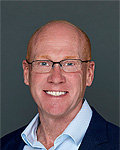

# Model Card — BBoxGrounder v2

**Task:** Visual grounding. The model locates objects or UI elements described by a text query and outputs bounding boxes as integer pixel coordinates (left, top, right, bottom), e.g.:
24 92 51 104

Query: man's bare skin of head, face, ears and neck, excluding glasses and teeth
23 21 95 149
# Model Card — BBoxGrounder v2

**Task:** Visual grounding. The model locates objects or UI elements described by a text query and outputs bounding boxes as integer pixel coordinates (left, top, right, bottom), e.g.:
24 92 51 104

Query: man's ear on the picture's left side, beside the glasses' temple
22 60 29 85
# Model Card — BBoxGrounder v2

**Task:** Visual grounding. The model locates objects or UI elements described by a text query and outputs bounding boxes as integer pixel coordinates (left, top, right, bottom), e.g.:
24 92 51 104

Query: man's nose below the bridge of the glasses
48 64 66 84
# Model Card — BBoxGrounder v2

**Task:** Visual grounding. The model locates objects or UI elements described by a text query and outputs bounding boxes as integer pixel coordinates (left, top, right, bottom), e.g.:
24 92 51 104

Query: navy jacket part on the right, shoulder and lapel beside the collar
80 107 120 150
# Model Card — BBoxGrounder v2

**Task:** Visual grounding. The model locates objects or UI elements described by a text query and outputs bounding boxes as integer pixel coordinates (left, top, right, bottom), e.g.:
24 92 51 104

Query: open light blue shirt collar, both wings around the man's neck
21 99 92 147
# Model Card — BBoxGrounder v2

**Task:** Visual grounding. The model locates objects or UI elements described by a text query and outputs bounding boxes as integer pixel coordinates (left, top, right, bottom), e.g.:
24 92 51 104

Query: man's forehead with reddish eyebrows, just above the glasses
31 38 79 61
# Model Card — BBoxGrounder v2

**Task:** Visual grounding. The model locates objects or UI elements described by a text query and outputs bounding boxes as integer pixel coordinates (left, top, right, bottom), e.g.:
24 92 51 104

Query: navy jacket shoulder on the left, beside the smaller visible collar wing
0 126 26 150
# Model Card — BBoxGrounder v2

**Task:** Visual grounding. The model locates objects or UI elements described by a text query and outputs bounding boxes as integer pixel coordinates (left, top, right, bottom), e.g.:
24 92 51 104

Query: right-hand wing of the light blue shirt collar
56 100 92 145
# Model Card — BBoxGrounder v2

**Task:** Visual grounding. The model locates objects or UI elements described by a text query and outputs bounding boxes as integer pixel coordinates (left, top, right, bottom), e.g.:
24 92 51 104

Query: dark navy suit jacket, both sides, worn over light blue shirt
1 108 120 150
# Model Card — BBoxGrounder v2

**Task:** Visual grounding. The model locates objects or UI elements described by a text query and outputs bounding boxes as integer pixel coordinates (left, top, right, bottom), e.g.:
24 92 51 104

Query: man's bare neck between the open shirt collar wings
37 116 69 149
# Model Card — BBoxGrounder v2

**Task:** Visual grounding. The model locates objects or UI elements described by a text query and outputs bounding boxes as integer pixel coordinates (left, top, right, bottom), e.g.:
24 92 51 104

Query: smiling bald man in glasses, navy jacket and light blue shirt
1 21 119 150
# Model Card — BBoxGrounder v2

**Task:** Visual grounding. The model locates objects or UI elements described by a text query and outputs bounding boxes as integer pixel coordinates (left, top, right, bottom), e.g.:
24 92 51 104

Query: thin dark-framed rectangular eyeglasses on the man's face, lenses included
26 59 91 73
